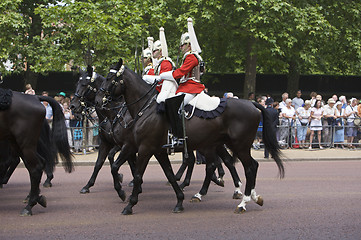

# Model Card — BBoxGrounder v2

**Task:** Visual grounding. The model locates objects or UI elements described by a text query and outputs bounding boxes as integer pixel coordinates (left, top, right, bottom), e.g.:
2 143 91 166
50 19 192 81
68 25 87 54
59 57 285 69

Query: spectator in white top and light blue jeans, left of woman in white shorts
296 100 311 148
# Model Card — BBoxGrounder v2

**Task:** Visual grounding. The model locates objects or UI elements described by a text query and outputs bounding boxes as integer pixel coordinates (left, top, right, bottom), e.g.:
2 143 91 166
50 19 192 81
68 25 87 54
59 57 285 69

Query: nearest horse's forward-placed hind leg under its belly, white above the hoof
191 152 219 202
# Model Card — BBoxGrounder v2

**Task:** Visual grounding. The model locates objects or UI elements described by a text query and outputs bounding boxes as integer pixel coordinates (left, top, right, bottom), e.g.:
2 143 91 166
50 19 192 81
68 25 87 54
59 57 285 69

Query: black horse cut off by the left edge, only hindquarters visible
0 92 73 215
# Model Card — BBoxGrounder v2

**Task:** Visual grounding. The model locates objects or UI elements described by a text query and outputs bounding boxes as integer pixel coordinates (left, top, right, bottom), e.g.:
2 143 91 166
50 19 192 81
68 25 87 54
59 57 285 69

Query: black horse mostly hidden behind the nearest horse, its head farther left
70 66 135 201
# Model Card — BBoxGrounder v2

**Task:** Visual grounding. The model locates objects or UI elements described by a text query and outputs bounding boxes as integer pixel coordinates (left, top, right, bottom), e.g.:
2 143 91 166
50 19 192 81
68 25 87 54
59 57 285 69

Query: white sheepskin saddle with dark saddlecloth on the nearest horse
184 92 227 119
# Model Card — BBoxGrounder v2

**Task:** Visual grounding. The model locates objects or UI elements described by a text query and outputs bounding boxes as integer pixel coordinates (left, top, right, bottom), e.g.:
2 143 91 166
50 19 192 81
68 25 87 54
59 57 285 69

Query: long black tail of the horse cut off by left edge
38 96 74 173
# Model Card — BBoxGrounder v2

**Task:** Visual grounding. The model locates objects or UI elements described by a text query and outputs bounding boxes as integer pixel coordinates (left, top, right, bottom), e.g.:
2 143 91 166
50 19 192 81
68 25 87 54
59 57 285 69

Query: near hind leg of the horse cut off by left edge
20 150 46 216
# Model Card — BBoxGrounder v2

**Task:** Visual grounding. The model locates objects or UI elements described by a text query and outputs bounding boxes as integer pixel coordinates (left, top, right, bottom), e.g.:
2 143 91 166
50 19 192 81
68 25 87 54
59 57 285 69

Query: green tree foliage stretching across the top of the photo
0 0 361 80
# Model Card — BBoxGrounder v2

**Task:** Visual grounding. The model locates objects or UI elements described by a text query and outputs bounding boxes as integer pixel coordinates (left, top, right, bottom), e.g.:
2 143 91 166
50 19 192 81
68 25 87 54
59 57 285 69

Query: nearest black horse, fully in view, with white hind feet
101 60 284 214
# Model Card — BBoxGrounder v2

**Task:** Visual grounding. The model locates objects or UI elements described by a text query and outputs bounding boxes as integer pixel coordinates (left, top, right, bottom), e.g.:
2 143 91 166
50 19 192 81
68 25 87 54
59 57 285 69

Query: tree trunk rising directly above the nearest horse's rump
243 37 257 98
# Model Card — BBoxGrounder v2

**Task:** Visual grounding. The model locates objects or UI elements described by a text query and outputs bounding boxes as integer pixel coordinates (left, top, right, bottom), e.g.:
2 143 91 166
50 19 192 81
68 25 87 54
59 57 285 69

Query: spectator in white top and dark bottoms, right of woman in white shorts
322 98 337 146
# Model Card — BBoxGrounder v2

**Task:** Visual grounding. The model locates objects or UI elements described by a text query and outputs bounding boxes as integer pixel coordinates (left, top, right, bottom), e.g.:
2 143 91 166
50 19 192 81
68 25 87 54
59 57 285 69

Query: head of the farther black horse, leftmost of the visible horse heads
70 65 98 119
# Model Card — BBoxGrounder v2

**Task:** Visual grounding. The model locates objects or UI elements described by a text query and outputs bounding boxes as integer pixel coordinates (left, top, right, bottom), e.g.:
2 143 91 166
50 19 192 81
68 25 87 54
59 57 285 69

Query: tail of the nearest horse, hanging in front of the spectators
252 102 285 178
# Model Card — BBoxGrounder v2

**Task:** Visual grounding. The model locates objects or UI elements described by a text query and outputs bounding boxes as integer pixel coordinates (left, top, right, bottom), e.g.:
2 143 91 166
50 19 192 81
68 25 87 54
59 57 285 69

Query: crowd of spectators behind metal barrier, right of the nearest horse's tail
249 90 361 154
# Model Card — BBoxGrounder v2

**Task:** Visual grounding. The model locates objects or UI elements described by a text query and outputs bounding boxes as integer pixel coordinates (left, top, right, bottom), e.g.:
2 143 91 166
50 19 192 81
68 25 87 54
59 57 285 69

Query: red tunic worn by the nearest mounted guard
173 54 205 94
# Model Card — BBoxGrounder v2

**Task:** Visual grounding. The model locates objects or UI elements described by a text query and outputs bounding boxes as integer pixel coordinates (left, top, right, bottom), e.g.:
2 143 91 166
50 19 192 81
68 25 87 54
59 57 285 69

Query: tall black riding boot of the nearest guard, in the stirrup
163 95 184 148
